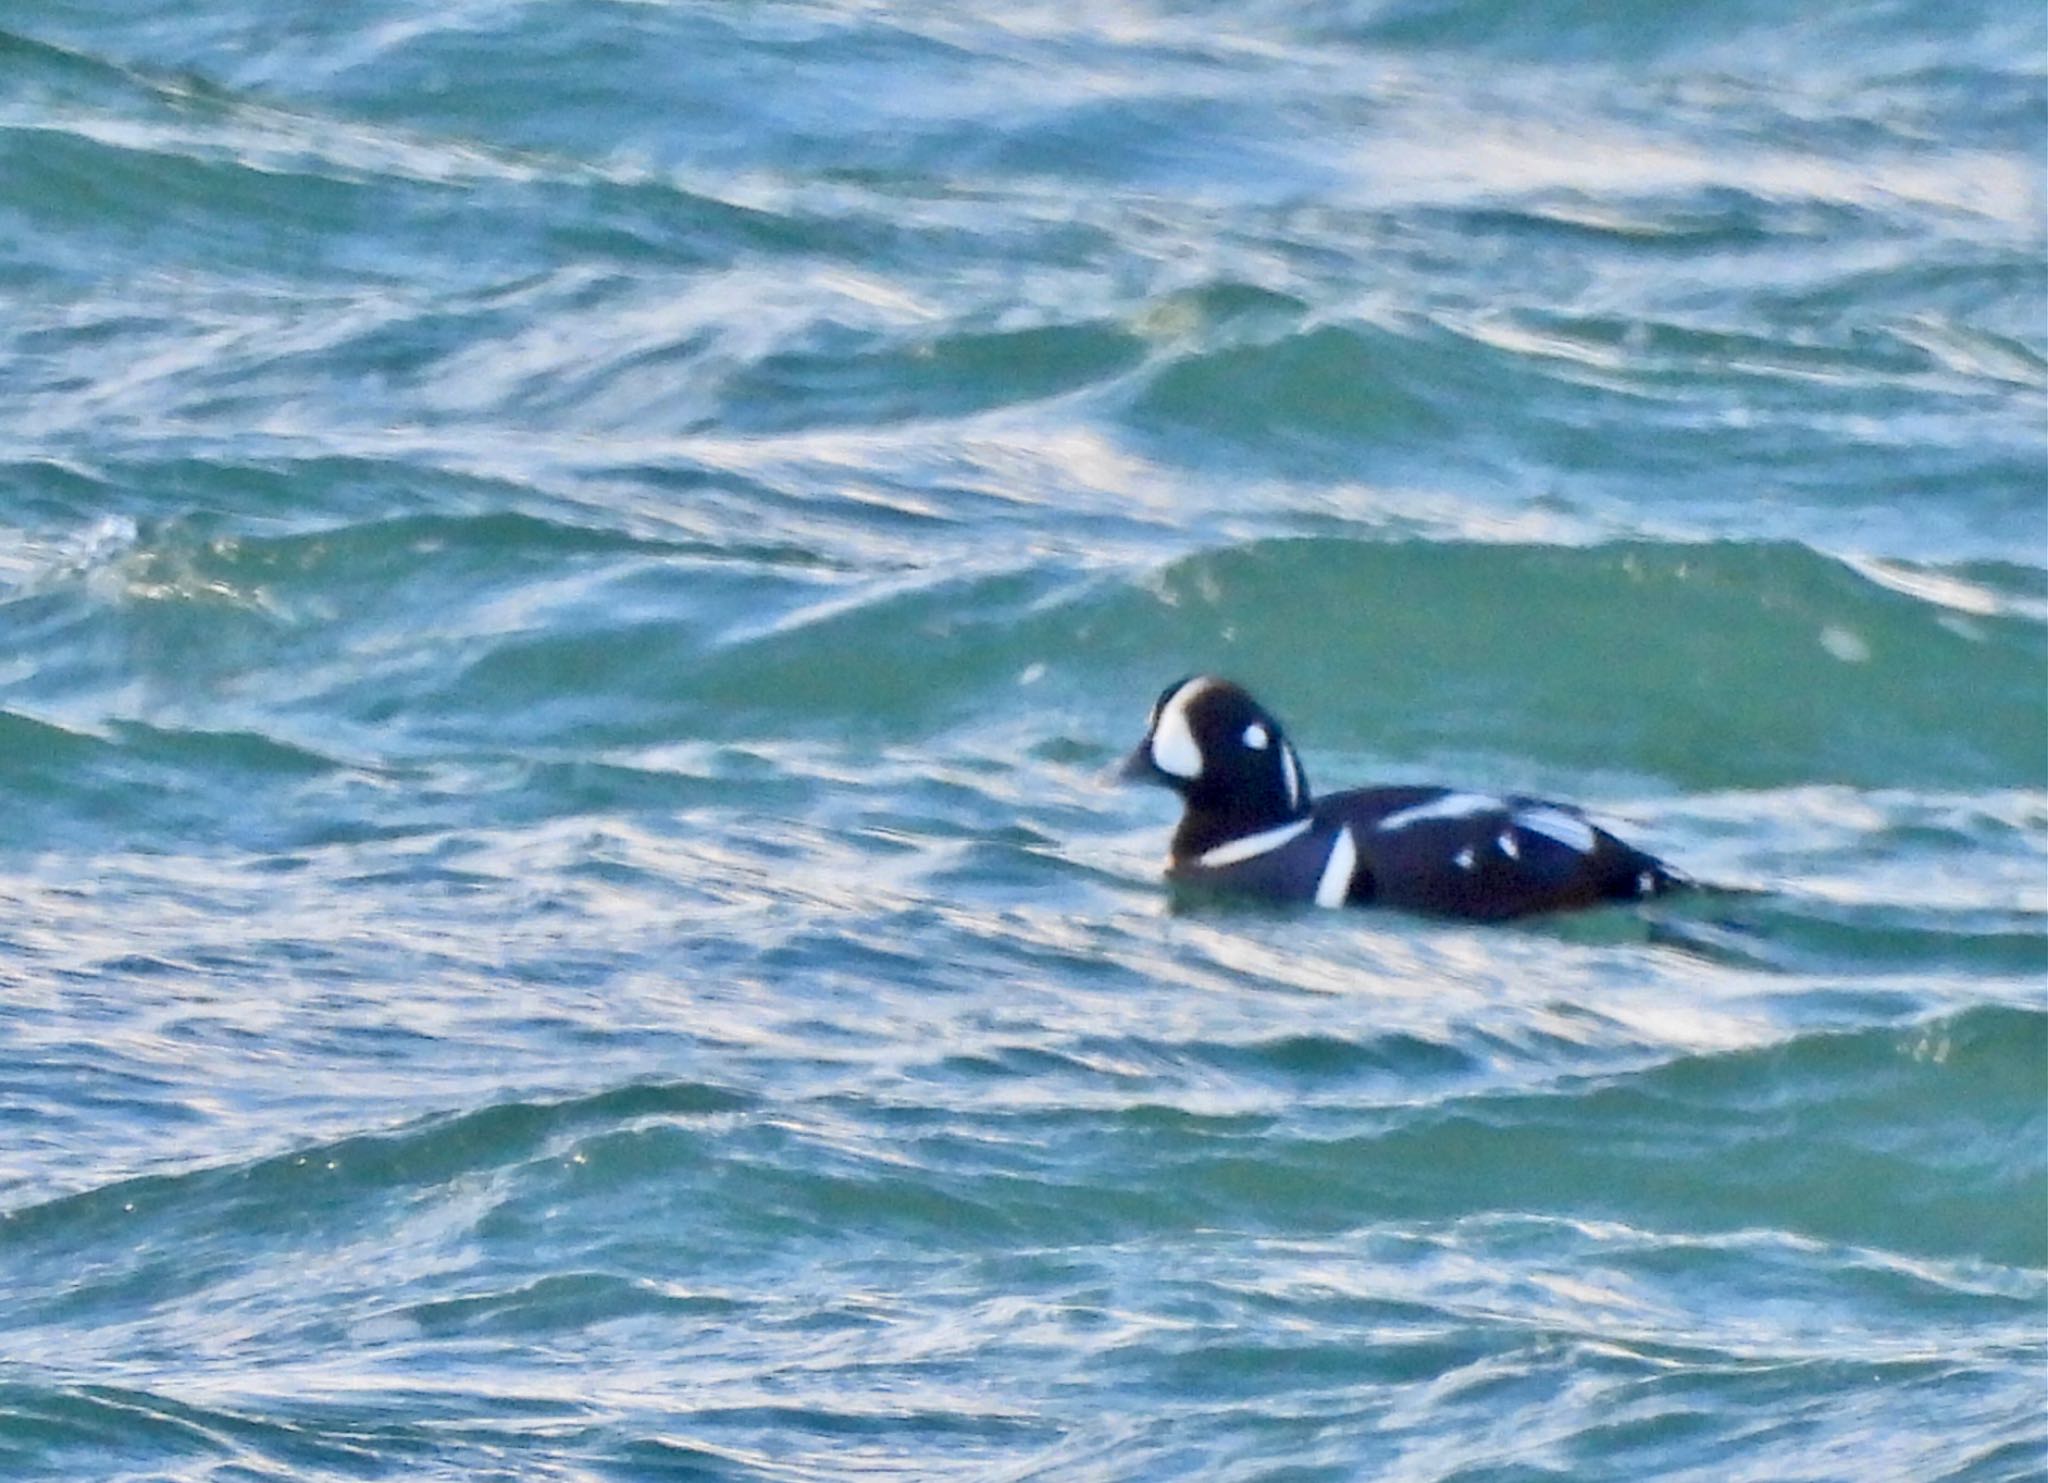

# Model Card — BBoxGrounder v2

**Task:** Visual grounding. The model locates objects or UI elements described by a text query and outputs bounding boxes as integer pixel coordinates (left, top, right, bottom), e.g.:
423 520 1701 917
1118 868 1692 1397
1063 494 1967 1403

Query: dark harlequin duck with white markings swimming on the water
1122 674 1686 922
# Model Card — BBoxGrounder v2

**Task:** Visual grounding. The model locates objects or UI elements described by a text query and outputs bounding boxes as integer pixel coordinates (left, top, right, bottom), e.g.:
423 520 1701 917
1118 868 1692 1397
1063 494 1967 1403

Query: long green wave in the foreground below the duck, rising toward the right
0 1006 2048 1278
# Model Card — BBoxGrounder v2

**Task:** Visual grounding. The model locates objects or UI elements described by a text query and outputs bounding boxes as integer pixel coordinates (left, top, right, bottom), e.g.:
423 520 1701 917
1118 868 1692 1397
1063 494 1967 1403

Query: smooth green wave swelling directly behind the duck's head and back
659 537 2048 789
